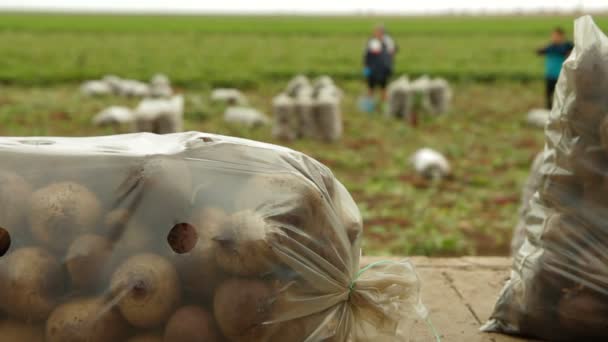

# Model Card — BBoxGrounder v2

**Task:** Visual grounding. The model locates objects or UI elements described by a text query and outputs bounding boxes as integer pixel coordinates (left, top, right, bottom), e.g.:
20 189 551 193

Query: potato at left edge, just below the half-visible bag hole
0 247 65 322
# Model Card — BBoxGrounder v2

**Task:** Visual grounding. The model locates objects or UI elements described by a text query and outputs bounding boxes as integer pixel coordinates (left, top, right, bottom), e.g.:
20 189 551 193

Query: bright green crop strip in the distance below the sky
0 13 608 89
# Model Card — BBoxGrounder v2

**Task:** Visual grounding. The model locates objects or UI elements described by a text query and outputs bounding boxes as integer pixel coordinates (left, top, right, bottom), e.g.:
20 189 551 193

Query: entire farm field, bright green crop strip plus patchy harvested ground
0 14 588 255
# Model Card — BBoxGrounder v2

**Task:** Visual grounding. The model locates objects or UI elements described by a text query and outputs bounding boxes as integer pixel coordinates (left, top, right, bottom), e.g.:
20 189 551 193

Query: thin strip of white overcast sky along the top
0 0 608 14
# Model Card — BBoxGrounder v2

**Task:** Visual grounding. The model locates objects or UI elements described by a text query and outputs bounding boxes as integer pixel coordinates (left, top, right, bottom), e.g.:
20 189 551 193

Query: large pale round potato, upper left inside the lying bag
29 182 101 251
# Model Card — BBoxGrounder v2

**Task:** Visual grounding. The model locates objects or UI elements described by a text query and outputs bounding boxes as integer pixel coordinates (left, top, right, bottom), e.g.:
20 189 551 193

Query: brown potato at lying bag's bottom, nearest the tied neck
213 278 274 341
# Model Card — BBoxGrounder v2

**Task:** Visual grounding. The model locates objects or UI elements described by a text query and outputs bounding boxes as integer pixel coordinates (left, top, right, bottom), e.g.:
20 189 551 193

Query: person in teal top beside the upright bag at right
536 27 574 109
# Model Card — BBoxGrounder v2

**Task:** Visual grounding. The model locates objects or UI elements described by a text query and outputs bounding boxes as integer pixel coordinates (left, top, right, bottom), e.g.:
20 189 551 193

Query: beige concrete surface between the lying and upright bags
361 257 533 342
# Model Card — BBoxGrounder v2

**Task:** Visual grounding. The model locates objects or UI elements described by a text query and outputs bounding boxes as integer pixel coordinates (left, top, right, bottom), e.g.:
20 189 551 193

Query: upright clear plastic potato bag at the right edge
483 16 608 341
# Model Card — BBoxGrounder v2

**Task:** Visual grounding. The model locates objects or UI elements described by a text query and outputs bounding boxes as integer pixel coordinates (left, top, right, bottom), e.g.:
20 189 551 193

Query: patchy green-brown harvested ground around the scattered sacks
0 81 543 255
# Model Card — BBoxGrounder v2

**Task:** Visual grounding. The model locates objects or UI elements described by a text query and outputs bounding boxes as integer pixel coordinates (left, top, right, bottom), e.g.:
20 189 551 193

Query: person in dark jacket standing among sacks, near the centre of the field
363 25 397 111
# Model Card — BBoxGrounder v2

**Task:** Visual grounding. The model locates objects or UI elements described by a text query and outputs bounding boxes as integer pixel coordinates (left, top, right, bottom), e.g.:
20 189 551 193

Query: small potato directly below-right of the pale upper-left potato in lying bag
65 234 112 289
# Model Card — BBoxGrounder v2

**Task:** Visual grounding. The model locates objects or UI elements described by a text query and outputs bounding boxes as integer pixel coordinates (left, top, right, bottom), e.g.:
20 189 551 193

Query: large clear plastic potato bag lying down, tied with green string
0 133 425 342
